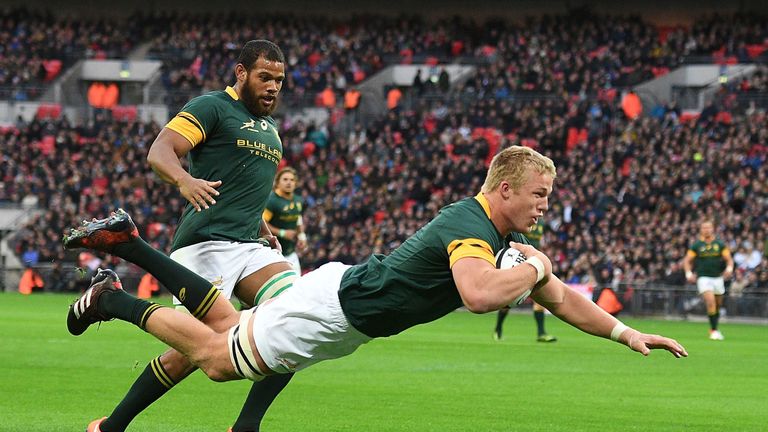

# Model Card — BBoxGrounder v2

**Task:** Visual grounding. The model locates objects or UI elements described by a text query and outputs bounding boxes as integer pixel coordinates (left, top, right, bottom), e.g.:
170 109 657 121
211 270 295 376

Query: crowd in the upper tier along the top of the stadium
0 9 768 108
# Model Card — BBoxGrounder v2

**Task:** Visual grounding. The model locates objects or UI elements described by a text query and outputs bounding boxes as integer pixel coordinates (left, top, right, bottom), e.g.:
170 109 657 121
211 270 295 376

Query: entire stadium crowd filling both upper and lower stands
0 9 768 296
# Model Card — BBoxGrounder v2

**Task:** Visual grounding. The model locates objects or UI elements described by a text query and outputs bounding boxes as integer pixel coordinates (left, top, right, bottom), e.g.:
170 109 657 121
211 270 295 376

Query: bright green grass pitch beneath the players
0 294 768 432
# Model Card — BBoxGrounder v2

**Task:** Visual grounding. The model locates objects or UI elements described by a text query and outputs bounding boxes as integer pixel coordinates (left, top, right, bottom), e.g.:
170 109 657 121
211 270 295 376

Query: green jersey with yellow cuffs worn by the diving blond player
339 194 528 337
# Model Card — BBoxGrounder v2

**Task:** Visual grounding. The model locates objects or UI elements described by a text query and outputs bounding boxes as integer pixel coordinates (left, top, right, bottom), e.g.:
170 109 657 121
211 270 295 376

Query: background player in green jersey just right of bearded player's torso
263 167 307 274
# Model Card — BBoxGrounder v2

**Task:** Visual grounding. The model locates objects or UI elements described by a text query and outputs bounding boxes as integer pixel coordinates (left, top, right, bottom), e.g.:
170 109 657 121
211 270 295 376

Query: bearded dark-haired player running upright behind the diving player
87 40 297 432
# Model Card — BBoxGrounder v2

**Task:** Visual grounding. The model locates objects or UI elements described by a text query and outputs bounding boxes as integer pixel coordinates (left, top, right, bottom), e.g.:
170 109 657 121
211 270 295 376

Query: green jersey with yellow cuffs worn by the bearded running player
166 87 283 250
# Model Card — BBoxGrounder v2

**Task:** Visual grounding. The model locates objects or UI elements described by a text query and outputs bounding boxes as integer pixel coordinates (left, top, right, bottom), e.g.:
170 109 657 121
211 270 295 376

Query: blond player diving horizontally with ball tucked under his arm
64 146 688 430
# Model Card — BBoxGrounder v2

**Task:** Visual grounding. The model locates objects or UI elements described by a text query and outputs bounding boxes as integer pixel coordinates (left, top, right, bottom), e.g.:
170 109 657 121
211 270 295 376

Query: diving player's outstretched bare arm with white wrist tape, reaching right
531 275 688 358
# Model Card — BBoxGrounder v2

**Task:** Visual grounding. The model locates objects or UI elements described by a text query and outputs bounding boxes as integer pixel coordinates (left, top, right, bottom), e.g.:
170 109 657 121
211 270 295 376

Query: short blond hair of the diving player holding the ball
481 146 557 193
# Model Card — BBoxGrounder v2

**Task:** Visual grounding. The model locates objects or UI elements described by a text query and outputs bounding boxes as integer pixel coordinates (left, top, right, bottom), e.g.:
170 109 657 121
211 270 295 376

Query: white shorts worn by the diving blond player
252 262 371 373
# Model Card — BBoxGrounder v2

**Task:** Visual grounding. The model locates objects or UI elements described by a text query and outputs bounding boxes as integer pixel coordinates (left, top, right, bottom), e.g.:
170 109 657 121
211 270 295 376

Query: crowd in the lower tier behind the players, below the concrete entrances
7 86 768 296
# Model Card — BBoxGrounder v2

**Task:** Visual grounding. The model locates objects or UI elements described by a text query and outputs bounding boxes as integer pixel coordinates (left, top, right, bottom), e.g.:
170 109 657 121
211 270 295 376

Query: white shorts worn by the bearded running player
171 240 287 305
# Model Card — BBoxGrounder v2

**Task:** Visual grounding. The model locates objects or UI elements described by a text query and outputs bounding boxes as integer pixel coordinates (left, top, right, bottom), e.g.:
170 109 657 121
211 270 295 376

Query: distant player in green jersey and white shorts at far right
683 220 733 340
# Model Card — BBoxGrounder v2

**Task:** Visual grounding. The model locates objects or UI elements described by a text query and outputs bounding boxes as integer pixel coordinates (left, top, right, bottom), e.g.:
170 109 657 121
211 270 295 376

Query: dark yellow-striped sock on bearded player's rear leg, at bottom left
100 357 176 432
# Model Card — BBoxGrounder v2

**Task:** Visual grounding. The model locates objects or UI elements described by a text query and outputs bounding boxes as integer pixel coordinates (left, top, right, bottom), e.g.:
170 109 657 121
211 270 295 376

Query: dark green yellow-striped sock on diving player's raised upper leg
113 239 219 319
